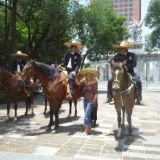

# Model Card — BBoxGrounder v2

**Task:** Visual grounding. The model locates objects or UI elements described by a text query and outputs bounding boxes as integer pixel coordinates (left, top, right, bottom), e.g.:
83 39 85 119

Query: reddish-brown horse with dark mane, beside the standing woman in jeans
21 61 82 131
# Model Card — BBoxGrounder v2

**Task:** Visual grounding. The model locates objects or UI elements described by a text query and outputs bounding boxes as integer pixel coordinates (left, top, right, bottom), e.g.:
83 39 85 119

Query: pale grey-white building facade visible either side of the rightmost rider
91 52 160 87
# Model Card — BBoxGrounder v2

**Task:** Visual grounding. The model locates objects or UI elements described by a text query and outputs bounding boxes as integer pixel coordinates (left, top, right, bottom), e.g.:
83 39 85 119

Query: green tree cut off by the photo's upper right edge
145 0 160 48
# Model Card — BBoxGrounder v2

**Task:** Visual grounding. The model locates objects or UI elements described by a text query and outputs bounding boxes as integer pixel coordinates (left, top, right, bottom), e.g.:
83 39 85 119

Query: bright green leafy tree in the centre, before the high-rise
68 0 127 60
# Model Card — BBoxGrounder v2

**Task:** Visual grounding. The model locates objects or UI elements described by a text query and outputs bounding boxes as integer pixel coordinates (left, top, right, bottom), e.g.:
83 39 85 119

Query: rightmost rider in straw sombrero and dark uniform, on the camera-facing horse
106 41 142 105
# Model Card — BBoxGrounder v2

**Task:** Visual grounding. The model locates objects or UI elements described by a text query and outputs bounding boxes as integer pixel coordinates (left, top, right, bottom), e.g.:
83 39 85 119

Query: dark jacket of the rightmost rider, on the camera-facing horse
113 52 137 74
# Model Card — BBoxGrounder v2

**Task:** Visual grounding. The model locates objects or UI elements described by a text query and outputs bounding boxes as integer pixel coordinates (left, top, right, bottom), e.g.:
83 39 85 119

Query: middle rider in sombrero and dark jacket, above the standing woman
62 40 83 99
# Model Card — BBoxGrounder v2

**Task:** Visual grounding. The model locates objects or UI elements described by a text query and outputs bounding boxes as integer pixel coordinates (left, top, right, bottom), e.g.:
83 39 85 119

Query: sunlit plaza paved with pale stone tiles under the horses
0 90 160 160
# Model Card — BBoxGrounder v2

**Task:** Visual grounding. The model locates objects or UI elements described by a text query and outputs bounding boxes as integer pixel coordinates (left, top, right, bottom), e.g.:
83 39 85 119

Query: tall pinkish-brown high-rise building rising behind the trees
90 0 141 25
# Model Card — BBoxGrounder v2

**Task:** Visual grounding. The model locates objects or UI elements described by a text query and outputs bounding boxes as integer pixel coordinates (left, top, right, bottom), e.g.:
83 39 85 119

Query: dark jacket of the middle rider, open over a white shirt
62 52 81 73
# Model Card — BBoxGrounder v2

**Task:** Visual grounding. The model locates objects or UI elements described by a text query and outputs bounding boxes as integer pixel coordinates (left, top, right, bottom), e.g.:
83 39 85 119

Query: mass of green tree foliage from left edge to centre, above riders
0 0 126 63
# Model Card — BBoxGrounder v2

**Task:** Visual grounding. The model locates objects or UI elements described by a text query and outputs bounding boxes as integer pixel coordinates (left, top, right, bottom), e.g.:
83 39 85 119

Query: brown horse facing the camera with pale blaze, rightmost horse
112 62 135 137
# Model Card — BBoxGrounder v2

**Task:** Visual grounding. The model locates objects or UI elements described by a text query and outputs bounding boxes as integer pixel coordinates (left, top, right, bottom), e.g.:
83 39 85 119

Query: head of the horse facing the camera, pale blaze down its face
112 61 126 91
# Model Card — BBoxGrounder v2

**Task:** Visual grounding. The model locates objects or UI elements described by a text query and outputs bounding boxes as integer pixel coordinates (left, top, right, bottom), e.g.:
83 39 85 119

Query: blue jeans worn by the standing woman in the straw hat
83 99 93 127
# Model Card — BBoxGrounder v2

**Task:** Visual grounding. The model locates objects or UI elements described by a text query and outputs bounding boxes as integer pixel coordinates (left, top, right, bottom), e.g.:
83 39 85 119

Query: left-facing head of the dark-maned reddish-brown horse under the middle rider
21 61 35 77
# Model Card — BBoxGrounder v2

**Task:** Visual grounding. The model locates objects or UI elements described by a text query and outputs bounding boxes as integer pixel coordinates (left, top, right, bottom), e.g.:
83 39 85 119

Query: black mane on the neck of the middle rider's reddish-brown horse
35 62 57 78
